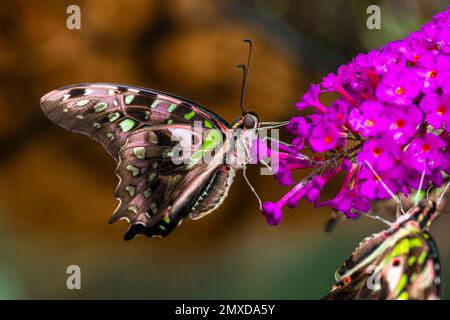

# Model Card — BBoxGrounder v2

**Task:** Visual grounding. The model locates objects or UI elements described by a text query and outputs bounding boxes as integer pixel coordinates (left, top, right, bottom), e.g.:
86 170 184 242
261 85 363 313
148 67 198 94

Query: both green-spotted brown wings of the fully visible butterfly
41 83 243 240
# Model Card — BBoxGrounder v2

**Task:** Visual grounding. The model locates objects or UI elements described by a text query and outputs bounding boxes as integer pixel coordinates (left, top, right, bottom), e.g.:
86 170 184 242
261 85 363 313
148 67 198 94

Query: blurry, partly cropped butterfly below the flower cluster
323 191 443 300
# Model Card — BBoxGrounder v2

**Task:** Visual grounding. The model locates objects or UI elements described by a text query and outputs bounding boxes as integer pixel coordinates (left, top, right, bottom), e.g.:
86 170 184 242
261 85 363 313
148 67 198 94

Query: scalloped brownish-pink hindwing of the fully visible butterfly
111 125 227 235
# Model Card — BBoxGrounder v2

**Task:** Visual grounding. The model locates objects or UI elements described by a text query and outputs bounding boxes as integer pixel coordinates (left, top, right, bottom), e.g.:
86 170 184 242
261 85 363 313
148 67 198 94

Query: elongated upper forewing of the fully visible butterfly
41 83 229 159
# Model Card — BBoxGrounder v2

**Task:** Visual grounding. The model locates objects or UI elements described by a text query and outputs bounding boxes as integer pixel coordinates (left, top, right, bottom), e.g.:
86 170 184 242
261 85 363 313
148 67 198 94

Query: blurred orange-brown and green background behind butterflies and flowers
0 0 450 299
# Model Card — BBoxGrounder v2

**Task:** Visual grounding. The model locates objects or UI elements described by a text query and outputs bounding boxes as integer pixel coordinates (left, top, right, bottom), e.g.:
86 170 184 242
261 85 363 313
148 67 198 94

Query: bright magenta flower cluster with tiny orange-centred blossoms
262 8 450 225
